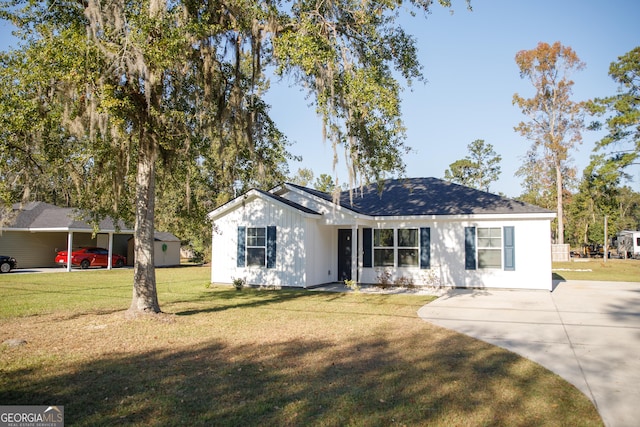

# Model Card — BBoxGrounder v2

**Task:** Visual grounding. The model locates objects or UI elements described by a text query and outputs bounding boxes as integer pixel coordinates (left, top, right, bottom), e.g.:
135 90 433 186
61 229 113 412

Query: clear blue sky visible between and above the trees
0 0 640 196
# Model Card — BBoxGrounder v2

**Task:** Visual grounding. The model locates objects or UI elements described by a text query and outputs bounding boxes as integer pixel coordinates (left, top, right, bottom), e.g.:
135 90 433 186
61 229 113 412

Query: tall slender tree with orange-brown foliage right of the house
513 42 584 244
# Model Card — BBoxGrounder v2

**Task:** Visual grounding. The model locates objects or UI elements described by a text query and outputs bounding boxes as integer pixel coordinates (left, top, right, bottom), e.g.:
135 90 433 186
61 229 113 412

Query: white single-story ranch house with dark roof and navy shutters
209 178 556 290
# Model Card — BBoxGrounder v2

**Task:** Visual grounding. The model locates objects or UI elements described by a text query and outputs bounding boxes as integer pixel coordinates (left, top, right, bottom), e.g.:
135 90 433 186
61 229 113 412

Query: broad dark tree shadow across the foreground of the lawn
0 331 599 426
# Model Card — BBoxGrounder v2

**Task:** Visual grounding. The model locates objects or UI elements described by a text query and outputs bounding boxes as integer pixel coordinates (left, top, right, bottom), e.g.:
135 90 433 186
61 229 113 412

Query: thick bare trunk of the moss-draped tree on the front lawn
129 130 160 315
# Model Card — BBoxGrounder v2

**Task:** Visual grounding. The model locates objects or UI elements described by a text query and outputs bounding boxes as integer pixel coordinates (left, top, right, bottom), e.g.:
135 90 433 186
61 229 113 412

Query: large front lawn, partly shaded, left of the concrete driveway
0 267 602 426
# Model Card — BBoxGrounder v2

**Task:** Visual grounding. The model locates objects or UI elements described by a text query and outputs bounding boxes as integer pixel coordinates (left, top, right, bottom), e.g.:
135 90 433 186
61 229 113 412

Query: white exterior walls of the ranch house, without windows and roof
211 191 552 290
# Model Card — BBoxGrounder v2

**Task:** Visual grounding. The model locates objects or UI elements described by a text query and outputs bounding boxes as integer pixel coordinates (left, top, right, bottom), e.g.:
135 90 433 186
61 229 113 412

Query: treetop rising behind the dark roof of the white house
444 139 502 191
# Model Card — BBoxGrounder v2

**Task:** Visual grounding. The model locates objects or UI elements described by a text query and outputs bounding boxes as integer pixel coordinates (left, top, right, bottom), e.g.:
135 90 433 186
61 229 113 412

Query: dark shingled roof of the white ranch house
288 178 553 216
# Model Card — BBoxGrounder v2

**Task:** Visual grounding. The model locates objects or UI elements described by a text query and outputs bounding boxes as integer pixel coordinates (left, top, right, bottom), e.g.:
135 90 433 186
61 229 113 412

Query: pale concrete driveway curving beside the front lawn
418 281 640 427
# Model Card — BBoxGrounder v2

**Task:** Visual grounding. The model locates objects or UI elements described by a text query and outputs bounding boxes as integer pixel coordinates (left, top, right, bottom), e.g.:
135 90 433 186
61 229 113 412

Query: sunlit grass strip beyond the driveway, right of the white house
553 258 640 282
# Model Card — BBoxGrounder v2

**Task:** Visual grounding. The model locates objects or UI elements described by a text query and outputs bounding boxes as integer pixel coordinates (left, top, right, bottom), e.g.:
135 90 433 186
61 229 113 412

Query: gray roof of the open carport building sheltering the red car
6 202 130 231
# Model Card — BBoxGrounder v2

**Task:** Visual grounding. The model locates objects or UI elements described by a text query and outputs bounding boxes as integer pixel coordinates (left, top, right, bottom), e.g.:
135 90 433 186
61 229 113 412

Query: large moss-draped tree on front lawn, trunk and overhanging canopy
0 0 470 313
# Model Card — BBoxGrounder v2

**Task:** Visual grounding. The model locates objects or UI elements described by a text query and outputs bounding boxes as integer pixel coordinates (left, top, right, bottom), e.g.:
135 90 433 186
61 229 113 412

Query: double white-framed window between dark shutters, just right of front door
373 228 420 267
